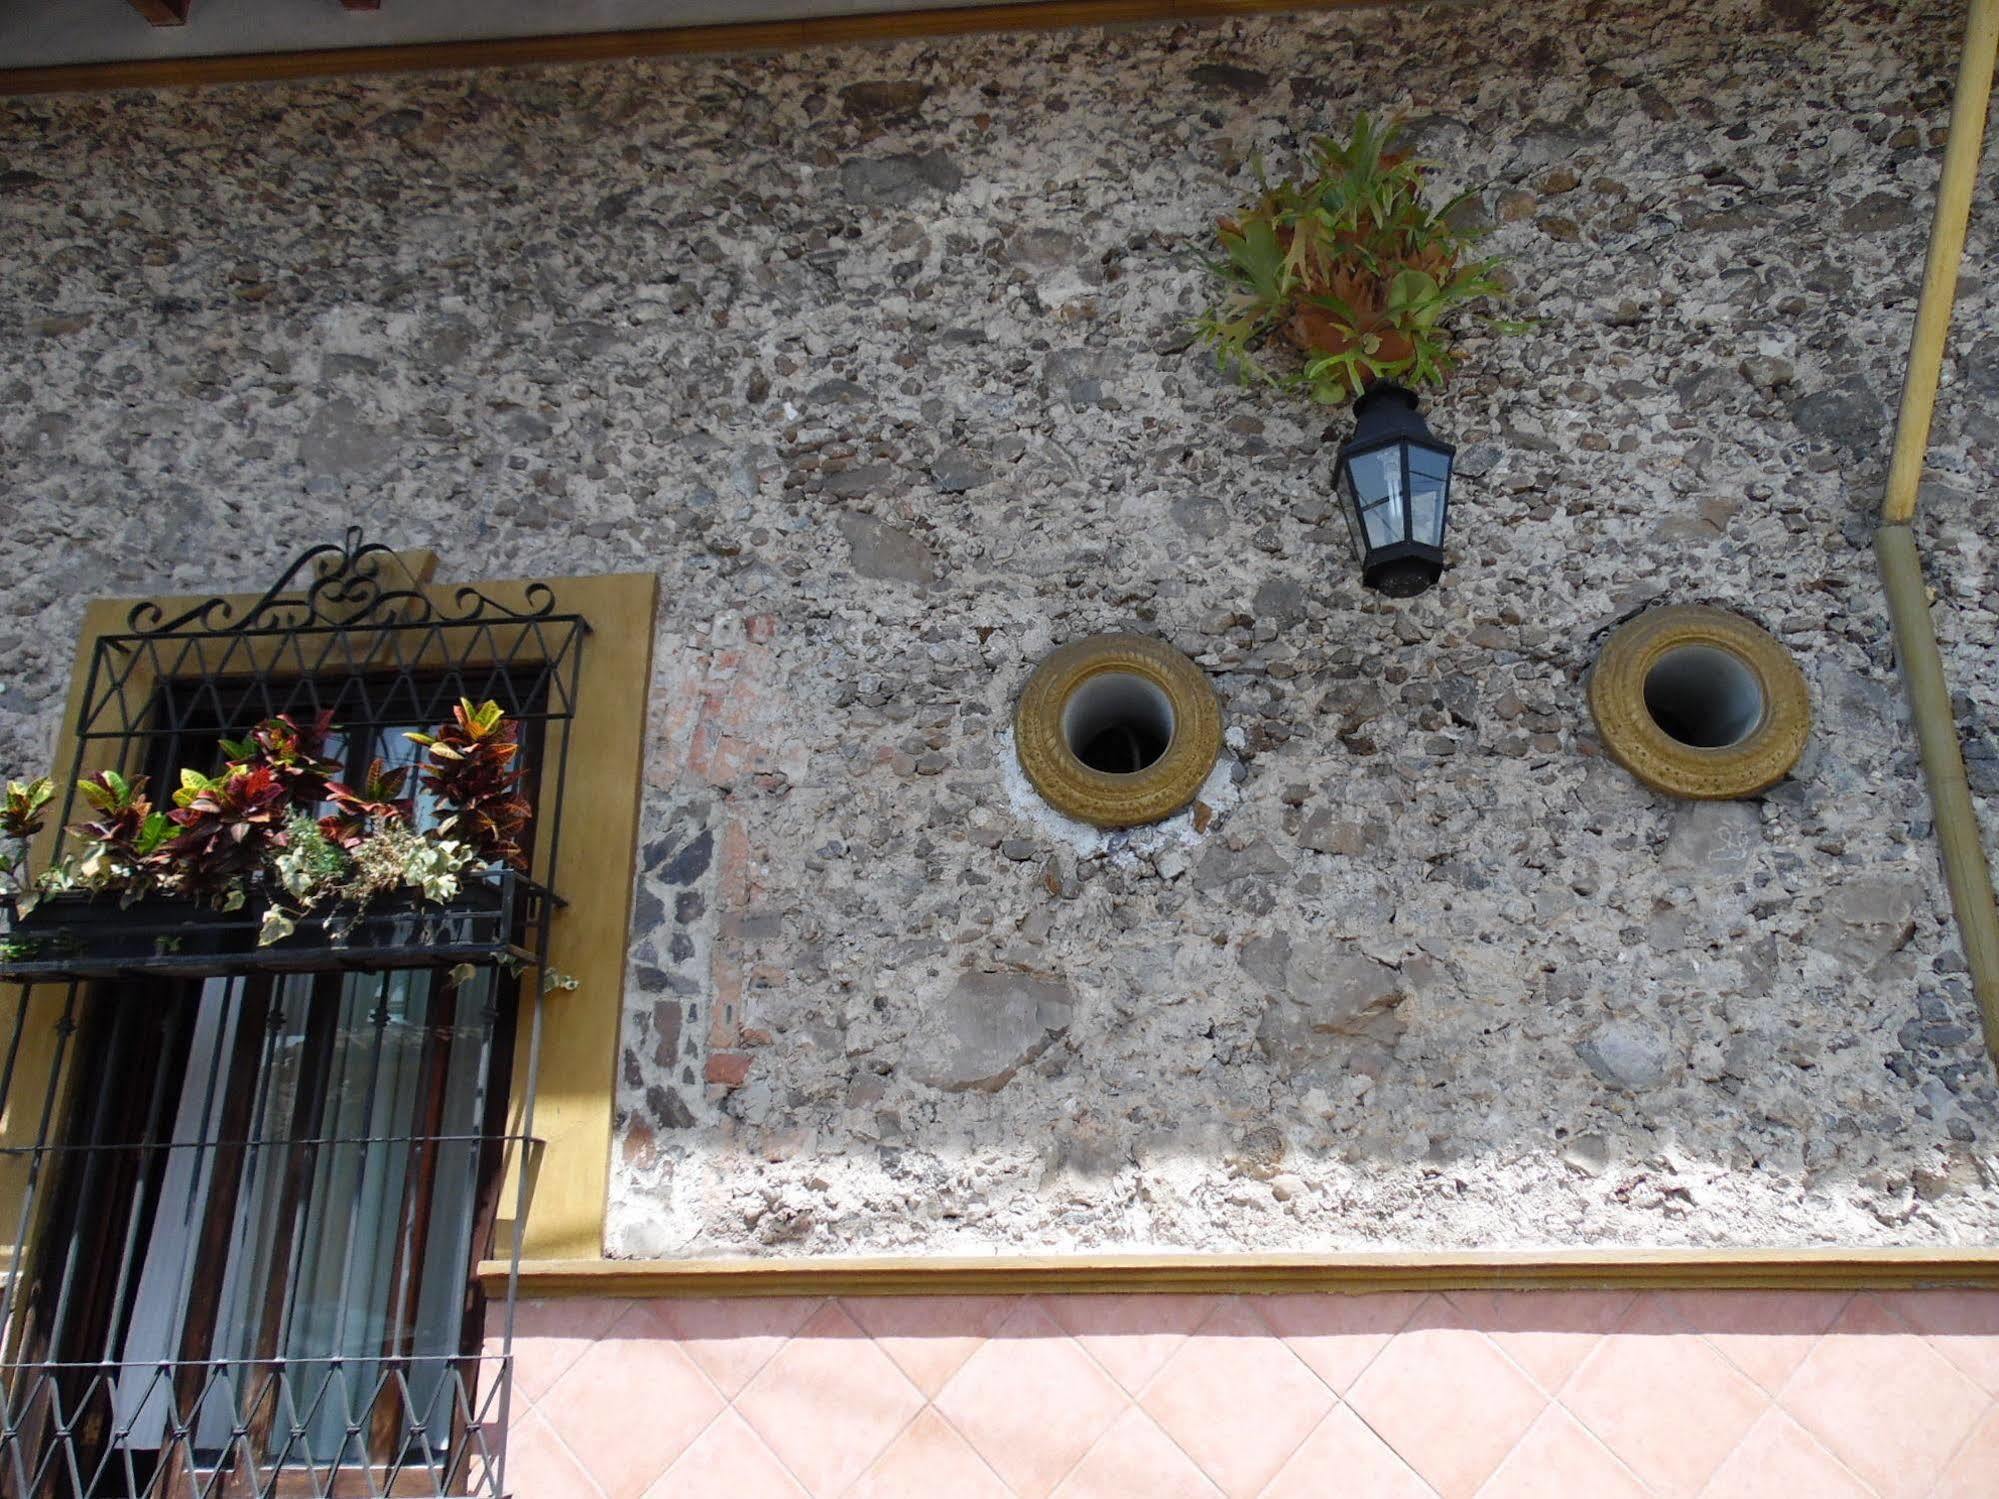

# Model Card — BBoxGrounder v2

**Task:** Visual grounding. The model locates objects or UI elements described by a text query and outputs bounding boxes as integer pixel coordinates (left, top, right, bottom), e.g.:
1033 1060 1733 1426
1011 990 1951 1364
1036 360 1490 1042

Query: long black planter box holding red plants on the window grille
0 869 560 983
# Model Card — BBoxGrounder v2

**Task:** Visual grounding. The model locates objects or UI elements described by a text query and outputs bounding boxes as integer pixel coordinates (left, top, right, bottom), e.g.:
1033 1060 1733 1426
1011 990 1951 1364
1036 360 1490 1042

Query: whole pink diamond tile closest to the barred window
536 1303 722 1499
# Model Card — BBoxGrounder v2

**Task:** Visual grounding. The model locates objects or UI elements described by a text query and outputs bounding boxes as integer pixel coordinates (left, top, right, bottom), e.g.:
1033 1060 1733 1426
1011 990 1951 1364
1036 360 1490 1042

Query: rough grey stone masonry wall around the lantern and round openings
0 0 1999 1255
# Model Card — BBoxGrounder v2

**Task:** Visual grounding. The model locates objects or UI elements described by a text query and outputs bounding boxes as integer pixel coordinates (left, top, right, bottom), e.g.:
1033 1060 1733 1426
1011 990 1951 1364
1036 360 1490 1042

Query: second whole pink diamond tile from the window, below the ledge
736 1303 924 1499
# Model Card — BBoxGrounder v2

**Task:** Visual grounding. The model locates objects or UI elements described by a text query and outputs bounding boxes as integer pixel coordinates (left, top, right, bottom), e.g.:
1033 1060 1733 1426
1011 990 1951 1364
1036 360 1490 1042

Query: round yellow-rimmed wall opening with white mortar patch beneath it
1013 636 1221 827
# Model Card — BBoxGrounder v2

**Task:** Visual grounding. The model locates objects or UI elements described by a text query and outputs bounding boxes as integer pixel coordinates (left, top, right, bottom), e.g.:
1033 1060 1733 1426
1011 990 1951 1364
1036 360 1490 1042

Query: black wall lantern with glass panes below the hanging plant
1337 382 1457 598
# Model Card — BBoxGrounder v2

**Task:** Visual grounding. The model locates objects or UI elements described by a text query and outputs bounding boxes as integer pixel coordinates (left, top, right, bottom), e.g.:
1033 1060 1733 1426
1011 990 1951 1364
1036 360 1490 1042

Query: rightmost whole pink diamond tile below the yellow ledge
1779 1293 1989 1499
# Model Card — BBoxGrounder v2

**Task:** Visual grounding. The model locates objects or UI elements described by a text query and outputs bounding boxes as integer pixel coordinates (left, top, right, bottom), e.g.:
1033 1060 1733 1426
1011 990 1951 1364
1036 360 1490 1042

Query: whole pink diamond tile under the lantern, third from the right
1347 1297 1547 1499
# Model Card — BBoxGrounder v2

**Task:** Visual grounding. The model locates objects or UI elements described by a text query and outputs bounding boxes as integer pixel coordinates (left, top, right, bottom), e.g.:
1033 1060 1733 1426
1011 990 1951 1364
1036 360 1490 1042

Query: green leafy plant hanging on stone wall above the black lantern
1195 114 1529 404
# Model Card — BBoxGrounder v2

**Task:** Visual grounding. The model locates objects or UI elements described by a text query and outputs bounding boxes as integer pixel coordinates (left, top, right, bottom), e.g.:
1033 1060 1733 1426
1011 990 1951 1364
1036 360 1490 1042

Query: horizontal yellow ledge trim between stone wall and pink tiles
480 1247 1999 1299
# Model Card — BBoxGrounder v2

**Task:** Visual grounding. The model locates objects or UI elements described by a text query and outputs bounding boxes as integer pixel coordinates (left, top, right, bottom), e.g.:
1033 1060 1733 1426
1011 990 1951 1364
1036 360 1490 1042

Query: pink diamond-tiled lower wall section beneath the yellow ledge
491 1291 1999 1499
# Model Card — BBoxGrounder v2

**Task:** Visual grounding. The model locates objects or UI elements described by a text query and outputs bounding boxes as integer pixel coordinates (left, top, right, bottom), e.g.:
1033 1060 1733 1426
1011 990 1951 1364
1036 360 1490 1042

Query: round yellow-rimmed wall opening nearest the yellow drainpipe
1589 604 1811 799
